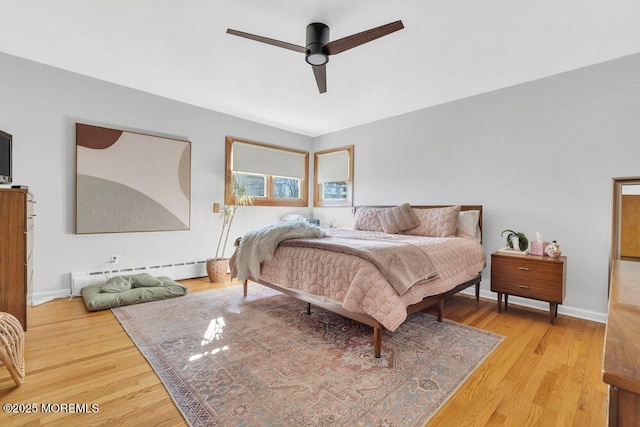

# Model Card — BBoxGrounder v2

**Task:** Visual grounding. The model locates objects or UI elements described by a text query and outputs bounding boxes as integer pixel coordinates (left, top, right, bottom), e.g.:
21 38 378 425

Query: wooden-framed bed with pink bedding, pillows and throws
231 203 486 357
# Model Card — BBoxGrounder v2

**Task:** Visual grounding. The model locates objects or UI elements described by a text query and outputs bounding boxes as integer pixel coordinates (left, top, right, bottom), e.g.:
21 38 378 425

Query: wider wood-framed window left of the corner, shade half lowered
225 137 309 206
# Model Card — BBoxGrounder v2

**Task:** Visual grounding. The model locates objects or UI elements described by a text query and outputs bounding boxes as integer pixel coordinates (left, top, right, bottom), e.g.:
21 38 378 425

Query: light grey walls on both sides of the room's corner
0 50 640 319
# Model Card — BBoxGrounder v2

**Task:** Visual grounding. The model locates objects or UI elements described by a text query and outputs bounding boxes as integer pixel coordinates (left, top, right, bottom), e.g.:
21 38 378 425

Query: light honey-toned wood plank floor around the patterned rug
0 278 607 427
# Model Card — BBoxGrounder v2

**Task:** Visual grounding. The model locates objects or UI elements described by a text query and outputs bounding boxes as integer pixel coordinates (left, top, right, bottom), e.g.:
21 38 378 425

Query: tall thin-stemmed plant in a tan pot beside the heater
207 176 253 283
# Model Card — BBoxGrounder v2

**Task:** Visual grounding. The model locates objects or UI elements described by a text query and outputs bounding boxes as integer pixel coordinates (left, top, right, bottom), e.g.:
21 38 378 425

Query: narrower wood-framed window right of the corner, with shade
313 145 353 207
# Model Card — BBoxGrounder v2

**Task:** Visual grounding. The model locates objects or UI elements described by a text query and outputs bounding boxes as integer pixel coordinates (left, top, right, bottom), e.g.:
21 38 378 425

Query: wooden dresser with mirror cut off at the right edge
602 260 640 426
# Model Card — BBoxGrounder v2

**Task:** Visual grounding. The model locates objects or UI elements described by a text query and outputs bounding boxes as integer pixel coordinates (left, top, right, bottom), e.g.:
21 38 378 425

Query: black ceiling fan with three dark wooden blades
227 21 404 93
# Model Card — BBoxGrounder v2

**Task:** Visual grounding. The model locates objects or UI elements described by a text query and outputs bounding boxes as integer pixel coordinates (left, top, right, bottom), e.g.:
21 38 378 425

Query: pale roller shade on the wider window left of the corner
231 142 305 179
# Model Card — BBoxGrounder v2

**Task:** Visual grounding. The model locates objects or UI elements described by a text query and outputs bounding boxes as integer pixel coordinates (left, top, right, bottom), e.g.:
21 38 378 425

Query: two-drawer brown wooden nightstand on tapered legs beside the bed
491 252 567 324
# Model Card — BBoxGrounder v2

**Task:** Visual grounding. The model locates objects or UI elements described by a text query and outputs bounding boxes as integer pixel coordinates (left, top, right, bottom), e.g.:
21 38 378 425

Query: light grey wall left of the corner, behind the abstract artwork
0 53 312 295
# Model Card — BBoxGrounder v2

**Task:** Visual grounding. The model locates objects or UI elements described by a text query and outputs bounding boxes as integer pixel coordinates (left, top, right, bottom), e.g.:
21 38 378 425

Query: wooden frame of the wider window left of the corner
224 136 309 207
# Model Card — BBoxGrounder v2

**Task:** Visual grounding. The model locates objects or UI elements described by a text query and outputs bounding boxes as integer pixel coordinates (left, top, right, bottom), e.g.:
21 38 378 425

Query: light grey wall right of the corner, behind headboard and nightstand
314 55 640 320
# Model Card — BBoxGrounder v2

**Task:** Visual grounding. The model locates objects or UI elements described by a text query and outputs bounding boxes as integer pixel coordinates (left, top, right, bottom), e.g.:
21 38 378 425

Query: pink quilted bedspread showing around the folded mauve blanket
254 229 485 331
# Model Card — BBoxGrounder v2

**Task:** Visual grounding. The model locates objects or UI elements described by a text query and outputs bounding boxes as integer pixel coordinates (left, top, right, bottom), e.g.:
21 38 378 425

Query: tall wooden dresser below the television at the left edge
0 189 35 331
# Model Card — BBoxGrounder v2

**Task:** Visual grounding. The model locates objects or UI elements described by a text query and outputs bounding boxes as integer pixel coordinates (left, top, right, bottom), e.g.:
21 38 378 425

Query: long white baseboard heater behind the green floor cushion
71 261 207 295
